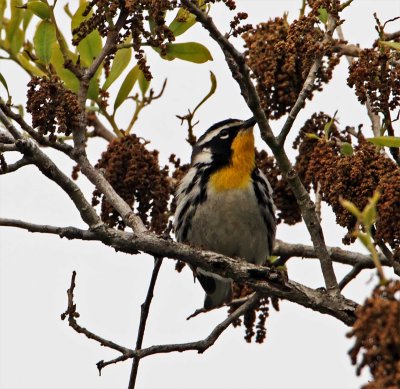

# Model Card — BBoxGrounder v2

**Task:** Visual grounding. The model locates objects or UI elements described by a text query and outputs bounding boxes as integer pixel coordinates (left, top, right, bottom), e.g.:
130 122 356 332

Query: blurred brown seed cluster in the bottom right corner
347 281 400 389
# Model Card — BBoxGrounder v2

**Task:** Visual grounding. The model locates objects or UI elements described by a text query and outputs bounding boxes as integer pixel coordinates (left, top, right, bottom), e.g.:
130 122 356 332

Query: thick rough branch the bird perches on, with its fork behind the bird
0 218 356 325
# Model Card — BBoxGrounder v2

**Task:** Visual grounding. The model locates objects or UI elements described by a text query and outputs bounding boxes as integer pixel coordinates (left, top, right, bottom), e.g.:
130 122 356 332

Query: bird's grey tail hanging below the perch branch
196 268 232 309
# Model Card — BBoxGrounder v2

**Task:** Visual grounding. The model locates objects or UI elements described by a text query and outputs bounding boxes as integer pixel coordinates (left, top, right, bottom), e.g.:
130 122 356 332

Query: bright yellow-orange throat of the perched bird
210 128 255 192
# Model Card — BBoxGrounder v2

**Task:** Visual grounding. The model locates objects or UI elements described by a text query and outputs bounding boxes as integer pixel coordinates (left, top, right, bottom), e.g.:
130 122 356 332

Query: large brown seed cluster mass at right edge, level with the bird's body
295 114 400 249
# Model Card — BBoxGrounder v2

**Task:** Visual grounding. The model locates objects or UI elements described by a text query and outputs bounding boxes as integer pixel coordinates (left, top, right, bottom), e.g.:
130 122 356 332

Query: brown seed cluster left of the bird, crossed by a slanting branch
92 135 171 234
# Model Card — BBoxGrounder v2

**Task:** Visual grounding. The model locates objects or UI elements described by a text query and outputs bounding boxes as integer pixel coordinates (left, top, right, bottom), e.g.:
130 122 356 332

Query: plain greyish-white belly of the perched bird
188 185 269 264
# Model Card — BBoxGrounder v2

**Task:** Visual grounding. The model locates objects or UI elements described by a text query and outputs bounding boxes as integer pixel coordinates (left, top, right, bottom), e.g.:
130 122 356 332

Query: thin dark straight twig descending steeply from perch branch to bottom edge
128 257 163 389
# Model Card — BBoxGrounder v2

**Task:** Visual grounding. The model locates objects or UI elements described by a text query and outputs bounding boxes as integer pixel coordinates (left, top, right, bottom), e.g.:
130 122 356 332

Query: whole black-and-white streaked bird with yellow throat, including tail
174 118 276 309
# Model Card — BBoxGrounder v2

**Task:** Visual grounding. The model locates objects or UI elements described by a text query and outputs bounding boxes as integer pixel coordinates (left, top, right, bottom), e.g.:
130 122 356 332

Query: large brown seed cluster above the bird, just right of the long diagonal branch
242 11 339 119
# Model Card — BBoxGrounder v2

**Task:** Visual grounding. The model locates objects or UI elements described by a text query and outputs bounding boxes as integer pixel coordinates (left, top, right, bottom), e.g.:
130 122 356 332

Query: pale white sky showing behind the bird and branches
0 0 400 389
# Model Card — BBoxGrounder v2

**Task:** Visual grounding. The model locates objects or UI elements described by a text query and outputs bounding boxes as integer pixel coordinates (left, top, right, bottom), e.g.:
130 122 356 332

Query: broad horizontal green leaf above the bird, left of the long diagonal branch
155 42 213 63
